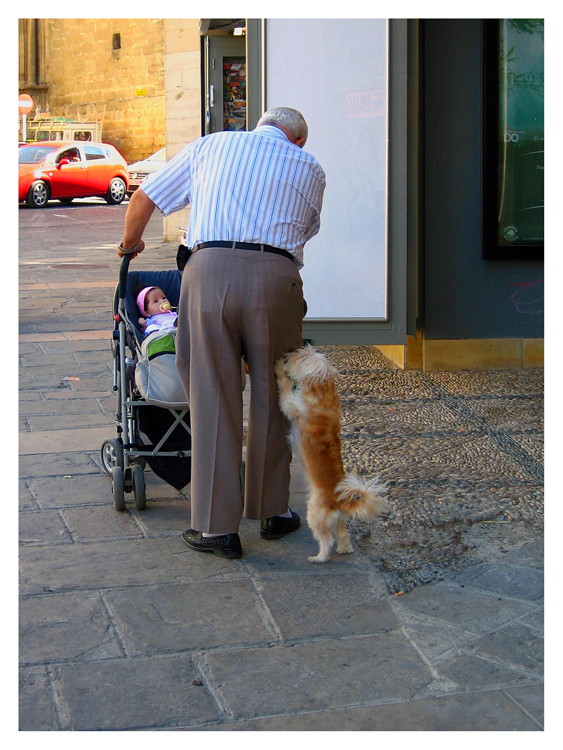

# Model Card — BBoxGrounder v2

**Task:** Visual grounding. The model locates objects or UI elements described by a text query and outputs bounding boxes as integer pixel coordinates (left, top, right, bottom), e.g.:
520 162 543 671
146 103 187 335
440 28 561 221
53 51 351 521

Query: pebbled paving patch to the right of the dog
320 346 544 593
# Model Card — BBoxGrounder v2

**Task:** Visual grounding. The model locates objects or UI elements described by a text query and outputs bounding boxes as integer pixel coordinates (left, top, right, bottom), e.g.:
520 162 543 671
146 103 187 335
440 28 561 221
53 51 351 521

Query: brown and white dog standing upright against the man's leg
275 345 391 563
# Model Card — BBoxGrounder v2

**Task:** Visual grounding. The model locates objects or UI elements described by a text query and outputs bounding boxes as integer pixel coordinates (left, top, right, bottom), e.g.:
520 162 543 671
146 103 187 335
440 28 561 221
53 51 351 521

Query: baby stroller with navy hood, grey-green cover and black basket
101 255 191 511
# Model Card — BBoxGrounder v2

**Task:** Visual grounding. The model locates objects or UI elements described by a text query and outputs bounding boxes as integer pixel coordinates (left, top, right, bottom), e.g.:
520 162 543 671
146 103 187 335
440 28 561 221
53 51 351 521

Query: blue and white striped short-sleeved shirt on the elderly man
142 125 326 268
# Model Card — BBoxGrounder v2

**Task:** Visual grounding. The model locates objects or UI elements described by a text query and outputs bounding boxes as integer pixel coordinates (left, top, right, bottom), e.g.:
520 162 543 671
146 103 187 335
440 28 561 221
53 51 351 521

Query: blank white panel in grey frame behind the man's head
265 19 388 320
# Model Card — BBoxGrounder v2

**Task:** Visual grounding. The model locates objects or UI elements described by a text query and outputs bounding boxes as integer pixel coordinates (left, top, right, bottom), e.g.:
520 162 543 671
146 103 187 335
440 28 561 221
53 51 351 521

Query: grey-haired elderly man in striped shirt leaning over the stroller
118 107 325 558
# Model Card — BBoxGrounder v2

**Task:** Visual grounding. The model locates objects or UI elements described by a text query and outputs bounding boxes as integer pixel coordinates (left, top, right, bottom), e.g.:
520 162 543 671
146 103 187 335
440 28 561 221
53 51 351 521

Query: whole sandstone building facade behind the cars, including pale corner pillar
19 18 208 239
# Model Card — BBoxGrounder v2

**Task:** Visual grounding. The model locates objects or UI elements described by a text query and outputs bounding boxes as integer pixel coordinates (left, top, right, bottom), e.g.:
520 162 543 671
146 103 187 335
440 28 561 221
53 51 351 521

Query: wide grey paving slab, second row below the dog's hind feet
202 633 432 718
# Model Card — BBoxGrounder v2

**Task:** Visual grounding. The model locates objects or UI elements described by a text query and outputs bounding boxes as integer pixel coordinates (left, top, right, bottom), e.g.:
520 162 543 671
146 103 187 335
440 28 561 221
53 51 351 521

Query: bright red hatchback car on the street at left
18 141 129 208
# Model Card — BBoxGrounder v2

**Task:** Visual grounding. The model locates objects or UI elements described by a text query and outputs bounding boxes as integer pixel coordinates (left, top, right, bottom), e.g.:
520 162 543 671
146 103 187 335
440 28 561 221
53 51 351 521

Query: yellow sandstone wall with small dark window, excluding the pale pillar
45 18 166 163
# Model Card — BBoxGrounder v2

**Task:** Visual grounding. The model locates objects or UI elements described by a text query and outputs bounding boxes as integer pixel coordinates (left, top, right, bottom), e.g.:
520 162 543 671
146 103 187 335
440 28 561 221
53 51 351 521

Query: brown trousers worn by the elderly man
176 247 303 534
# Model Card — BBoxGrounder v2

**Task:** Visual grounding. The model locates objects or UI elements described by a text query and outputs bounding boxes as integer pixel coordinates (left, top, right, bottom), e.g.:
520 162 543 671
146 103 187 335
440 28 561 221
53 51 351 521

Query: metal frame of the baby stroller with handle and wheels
101 255 191 511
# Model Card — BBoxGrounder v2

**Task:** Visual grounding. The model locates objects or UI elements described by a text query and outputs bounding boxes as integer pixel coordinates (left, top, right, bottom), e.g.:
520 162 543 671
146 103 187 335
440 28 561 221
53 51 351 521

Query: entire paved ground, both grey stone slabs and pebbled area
18 201 544 741
